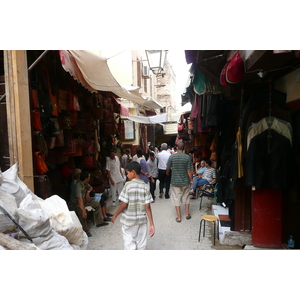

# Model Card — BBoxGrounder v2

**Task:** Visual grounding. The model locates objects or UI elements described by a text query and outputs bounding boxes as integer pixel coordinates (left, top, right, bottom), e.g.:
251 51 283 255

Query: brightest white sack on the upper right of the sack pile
39 195 73 232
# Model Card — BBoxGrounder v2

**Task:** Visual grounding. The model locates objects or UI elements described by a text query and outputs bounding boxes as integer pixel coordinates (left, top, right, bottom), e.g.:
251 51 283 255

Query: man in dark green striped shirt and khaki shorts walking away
166 142 193 223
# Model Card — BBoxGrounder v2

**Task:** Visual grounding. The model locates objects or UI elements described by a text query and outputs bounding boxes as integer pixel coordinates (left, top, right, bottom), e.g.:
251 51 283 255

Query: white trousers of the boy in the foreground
122 223 148 250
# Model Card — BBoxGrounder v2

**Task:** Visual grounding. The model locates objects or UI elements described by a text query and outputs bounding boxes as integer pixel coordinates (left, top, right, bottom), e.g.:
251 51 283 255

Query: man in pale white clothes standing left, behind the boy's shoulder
106 150 124 206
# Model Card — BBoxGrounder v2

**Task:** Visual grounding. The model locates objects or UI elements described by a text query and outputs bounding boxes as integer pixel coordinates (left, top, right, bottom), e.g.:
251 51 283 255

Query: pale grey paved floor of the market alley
87 190 241 250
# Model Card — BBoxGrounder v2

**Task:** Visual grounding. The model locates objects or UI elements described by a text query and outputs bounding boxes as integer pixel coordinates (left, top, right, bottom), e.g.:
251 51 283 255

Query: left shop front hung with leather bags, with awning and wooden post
3 50 161 209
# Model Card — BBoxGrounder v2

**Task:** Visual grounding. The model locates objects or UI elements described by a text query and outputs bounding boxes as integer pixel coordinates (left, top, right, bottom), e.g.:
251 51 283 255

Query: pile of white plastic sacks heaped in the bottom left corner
0 163 88 250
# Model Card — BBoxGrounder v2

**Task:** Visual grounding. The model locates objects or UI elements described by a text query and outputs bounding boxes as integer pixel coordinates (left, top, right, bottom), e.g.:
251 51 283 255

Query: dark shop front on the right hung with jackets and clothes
182 50 300 248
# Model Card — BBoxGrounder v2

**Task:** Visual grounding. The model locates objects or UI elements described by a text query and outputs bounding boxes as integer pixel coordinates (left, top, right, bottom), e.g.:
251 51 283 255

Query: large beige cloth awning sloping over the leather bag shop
59 50 161 109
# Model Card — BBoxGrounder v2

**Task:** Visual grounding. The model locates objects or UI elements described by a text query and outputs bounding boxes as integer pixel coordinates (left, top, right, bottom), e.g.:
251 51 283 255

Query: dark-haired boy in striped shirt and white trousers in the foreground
111 162 155 250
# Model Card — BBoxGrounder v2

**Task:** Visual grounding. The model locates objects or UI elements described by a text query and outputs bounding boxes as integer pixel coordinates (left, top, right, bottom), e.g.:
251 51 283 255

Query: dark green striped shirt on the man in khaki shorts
167 152 193 186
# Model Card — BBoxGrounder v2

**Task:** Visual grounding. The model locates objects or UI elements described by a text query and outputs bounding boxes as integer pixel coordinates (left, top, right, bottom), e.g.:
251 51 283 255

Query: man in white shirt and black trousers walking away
156 143 171 199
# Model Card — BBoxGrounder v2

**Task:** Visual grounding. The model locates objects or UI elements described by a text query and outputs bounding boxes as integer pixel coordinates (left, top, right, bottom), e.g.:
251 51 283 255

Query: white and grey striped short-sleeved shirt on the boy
119 179 153 226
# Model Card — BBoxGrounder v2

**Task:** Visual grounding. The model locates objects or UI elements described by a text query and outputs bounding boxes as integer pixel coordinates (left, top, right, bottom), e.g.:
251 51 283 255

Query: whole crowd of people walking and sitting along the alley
69 142 216 250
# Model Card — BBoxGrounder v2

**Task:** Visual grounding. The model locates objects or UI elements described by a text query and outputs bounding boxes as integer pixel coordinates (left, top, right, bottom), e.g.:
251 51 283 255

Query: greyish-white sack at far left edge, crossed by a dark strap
0 191 17 232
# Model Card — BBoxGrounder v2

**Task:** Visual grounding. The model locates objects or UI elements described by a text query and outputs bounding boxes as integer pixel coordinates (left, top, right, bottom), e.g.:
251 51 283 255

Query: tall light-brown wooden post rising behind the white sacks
4 50 34 192
